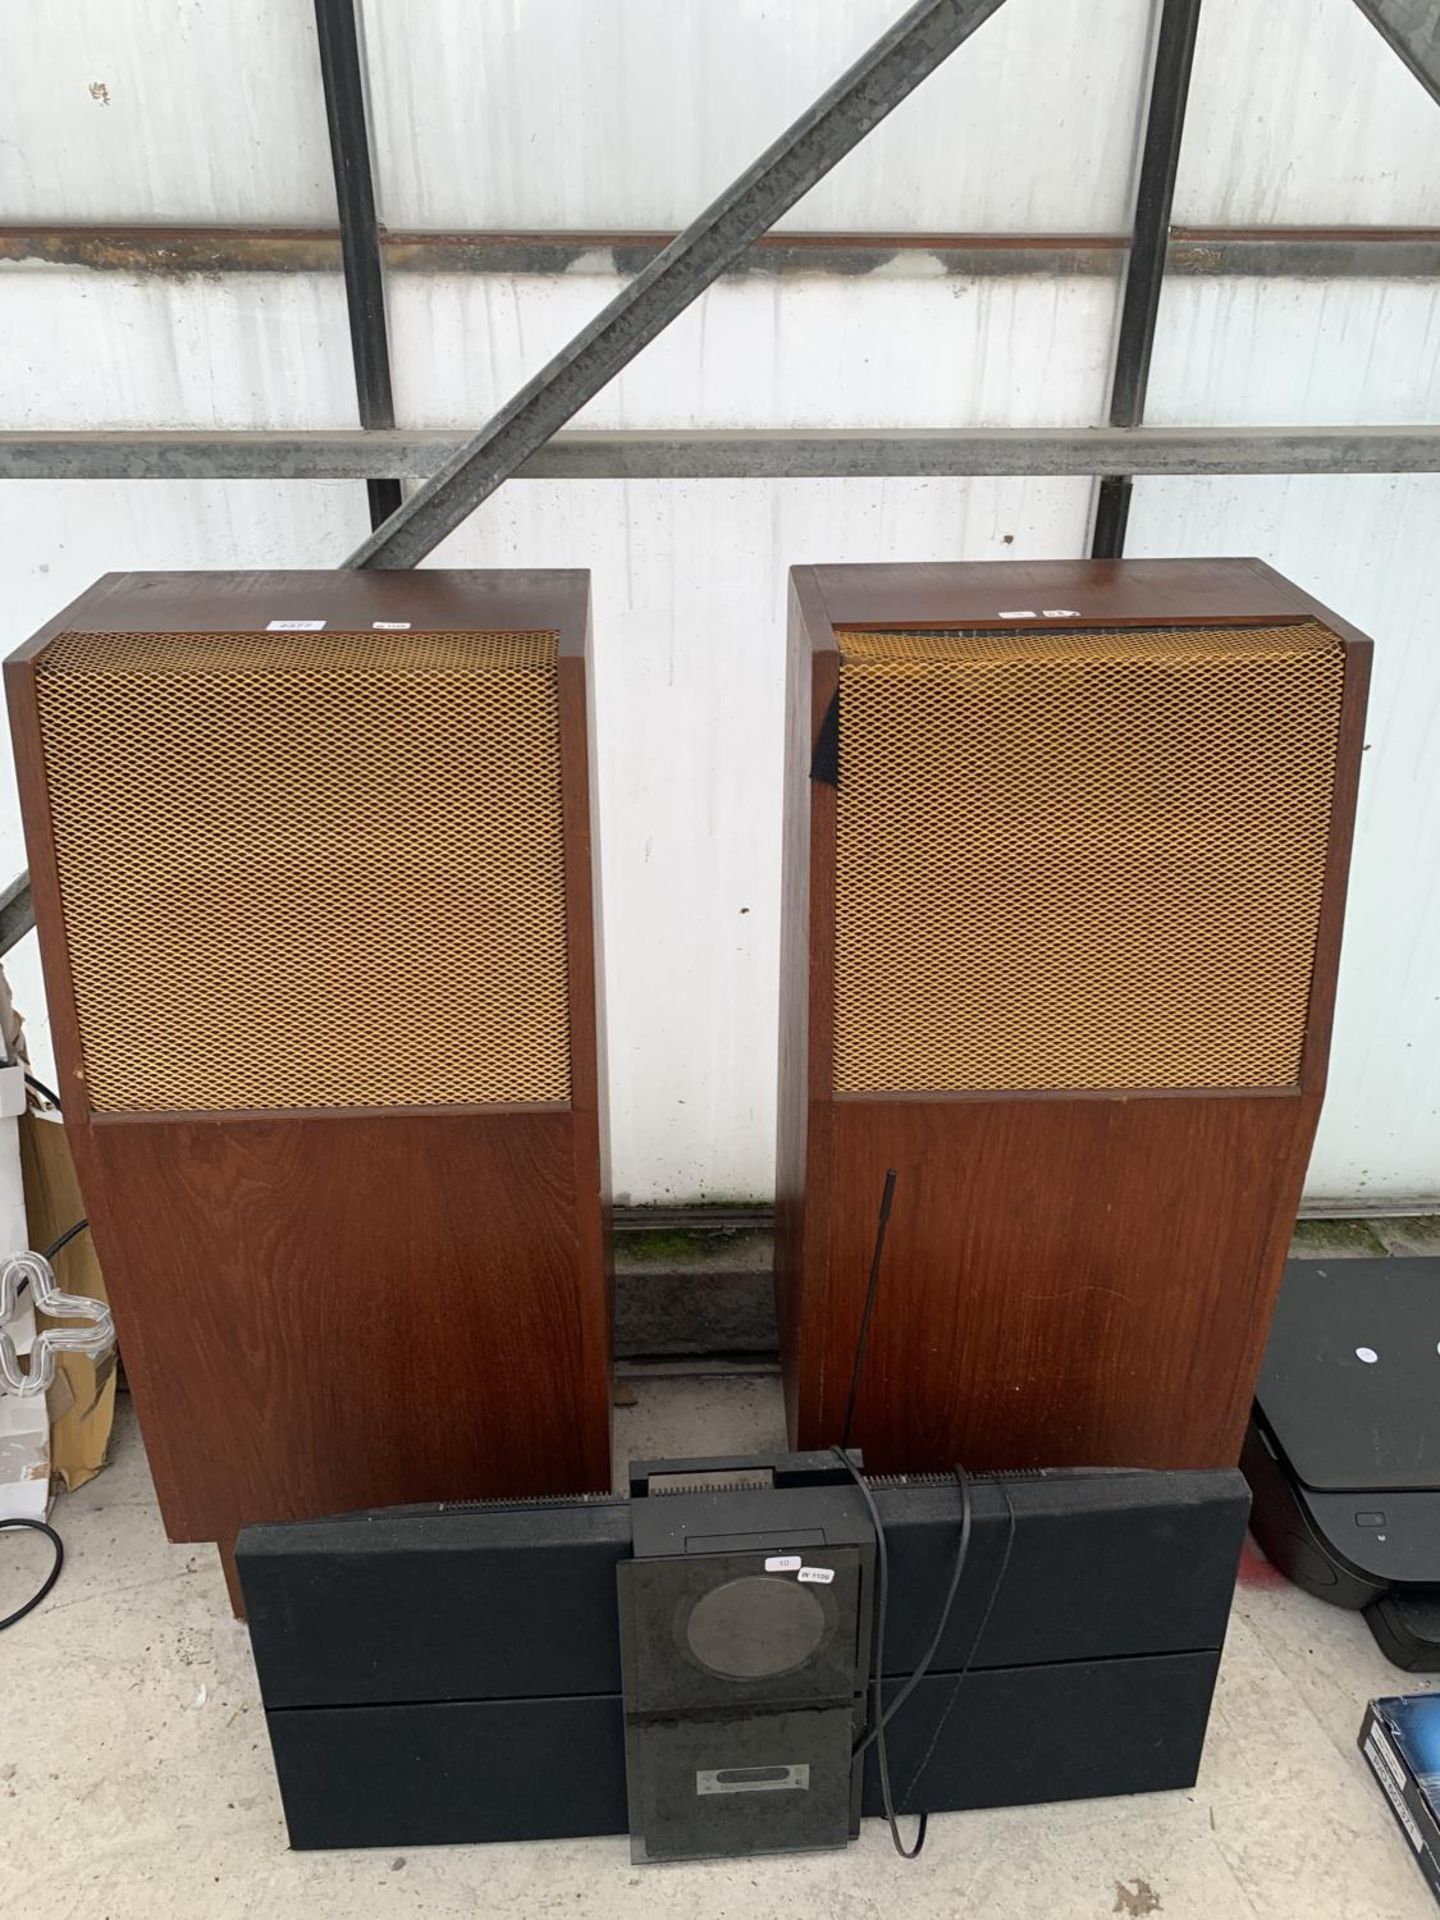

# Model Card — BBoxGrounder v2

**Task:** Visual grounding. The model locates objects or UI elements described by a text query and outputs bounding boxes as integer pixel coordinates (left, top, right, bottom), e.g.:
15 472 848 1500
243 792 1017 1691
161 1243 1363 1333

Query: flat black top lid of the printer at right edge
1256 1260 1440 1492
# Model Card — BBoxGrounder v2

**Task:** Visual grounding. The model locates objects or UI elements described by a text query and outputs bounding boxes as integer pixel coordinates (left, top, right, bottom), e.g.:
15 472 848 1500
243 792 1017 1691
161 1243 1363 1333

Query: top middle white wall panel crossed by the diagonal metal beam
365 0 1150 232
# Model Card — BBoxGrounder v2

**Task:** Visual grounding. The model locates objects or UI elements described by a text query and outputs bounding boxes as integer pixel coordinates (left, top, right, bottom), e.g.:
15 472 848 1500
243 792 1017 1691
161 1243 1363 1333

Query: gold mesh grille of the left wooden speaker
36 632 570 1110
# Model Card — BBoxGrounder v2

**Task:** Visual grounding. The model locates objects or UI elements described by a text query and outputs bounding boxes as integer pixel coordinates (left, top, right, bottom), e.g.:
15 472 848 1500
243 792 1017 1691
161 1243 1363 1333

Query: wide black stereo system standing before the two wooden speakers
238 1453 1248 1859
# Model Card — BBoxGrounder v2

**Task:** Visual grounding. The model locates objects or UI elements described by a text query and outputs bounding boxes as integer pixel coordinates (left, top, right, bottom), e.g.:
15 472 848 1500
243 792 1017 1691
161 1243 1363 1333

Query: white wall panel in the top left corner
0 0 336 227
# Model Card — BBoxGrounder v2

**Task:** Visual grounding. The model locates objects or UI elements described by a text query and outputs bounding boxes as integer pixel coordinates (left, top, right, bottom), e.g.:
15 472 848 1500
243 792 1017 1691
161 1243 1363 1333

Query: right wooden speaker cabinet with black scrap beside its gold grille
776 561 1371 1471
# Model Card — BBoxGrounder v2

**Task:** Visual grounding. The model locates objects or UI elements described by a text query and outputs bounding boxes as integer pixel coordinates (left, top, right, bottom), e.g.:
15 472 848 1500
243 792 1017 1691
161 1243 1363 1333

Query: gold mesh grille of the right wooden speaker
835 622 1344 1092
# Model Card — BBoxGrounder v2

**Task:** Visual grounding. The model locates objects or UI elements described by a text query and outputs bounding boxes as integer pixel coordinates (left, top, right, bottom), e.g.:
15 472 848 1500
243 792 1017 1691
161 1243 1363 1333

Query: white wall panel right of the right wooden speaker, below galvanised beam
1127 474 1440 1206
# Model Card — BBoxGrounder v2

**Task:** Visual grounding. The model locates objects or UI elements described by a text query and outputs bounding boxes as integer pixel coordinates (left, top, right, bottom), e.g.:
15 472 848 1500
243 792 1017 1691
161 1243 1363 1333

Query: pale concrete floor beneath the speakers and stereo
0 1375 1436 1920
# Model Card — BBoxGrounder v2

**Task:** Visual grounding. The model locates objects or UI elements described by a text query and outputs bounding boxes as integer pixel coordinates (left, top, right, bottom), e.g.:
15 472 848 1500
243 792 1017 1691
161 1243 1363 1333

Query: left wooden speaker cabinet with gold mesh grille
6 570 611 1605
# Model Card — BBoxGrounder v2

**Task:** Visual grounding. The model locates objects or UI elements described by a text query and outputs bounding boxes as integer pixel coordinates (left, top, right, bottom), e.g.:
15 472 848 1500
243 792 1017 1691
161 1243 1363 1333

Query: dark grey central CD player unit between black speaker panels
616 1455 876 1860
